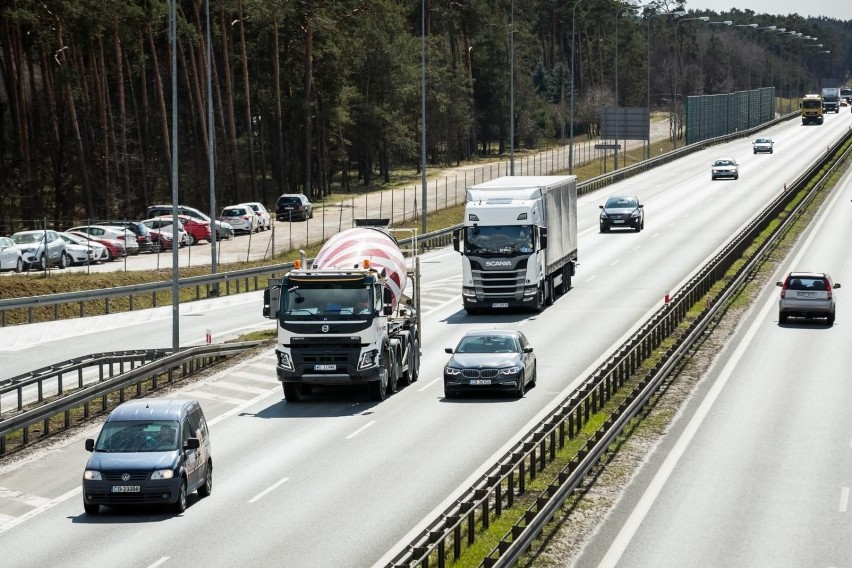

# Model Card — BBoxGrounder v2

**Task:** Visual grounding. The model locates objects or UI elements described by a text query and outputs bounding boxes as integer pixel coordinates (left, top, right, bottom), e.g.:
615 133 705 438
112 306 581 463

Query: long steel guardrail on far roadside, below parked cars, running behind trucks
0 113 799 327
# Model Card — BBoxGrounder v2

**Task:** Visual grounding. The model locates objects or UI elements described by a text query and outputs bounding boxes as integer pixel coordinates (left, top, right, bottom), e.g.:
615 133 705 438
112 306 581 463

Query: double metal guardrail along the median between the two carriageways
389 123 852 567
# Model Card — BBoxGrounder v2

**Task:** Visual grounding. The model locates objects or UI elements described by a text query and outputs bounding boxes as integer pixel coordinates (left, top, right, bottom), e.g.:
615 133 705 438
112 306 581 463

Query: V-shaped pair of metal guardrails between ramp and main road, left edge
0 341 262 456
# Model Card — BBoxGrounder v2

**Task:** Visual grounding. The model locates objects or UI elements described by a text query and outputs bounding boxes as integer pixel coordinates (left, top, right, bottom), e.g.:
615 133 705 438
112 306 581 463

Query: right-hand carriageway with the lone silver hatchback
576 153 852 568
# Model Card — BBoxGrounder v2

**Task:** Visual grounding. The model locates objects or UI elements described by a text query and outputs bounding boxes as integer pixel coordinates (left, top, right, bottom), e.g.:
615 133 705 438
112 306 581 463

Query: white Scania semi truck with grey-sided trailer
453 176 577 314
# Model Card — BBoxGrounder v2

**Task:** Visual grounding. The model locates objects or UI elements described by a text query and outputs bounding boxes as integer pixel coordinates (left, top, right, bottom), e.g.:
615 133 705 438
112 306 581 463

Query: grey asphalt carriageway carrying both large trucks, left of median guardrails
0 114 852 567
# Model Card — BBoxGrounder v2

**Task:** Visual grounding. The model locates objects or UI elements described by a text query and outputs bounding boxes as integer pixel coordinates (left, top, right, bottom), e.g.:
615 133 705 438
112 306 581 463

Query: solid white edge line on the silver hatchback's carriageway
598 161 842 568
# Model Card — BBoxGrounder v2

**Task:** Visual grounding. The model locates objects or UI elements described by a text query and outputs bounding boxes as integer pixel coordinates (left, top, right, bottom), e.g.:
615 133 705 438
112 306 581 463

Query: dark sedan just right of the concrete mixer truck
444 329 536 398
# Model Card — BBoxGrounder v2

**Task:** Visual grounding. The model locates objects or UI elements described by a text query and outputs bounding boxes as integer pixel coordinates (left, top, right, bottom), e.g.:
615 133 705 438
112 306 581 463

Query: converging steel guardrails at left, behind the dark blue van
0 341 263 456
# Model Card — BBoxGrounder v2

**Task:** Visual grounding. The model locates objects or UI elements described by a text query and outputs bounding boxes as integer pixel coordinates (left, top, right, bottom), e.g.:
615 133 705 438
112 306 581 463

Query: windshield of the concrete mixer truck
281 280 375 320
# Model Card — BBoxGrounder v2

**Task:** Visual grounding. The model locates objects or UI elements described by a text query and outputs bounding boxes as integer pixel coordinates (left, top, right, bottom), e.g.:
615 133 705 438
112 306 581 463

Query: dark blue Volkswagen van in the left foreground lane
83 398 213 515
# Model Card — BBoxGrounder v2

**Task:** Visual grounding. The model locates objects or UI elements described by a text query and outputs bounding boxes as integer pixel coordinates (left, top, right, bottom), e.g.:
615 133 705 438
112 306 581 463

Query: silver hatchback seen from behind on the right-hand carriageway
776 272 840 325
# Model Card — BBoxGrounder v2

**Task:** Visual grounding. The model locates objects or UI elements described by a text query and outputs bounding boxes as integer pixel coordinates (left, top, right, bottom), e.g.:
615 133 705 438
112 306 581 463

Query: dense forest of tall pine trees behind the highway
0 0 852 232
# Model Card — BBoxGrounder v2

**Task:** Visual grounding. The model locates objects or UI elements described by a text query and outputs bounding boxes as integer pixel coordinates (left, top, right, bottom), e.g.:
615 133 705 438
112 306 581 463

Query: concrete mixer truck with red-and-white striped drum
263 219 420 402
